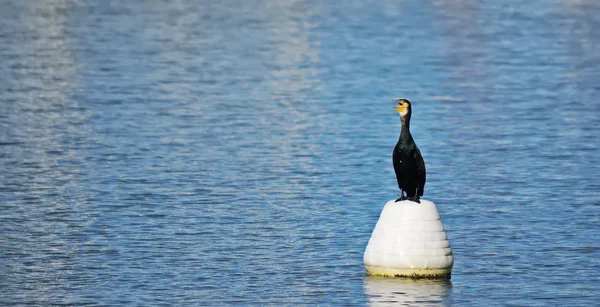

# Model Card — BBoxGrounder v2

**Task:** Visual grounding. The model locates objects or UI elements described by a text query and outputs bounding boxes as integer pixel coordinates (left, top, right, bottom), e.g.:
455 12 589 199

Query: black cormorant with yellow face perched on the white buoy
392 99 426 203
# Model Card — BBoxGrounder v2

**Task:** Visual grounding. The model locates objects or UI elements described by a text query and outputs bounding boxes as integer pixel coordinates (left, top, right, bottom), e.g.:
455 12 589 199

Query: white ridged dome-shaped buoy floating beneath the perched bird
364 199 454 278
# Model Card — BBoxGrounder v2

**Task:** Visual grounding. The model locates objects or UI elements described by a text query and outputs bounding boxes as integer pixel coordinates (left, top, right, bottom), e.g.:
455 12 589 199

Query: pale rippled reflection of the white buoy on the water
364 276 452 307
